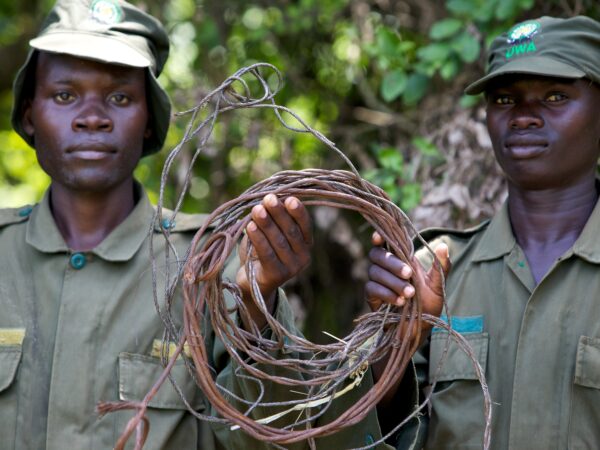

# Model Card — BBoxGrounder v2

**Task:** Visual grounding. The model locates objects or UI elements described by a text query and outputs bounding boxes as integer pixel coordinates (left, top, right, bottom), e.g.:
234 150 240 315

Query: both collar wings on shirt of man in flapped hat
26 185 154 261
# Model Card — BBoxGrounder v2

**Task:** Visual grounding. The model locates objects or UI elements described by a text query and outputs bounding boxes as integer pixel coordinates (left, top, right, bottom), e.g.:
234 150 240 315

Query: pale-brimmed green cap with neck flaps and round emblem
11 0 171 155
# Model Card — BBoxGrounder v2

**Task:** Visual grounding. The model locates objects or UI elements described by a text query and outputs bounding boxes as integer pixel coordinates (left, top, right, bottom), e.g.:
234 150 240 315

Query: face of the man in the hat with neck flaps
23 52 150 193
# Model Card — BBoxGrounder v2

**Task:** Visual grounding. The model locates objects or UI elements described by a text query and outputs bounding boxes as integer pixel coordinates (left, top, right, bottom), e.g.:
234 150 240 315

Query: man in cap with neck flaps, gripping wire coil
0 0 392 450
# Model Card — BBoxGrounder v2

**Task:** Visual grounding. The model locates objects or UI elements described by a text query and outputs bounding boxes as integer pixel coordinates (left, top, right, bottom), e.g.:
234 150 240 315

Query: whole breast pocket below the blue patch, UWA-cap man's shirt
427 331 489 448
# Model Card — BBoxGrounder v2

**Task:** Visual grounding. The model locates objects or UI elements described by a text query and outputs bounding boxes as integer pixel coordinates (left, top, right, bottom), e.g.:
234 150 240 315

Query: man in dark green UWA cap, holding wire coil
366 17 600 450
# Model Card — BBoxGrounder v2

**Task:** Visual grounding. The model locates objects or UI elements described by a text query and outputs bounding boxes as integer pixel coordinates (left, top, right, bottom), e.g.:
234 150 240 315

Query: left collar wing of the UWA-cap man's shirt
473 202 517 262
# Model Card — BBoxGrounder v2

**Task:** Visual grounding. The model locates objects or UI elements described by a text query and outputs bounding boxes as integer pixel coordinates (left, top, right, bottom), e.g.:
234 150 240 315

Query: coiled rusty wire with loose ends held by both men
98 63 491 450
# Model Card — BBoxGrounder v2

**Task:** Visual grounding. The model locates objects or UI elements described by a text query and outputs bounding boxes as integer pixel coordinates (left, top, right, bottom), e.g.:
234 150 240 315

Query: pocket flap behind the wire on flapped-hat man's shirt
119 353 203 410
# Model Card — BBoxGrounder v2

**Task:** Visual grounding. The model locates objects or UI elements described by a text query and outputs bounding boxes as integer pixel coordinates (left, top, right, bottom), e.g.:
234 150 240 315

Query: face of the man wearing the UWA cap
486 75 600 190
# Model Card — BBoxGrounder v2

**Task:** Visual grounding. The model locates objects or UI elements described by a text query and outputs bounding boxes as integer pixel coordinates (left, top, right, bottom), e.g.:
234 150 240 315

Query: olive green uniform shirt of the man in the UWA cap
400 205 600 450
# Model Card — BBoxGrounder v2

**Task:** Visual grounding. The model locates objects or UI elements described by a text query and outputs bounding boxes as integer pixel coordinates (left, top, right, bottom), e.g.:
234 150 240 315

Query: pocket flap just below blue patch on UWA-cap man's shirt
429 332 489 382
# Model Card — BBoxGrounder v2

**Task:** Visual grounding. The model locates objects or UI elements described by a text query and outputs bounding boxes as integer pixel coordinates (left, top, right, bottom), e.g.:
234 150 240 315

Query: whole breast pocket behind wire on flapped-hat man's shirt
113 353 204 449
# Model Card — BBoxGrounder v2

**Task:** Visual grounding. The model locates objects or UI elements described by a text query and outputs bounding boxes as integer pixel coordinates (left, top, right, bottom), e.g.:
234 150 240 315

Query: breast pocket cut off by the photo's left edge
0 345 21 449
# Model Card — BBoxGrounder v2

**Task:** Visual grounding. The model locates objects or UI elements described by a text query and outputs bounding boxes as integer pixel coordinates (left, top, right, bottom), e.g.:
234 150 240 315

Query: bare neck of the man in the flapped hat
50 179 136 251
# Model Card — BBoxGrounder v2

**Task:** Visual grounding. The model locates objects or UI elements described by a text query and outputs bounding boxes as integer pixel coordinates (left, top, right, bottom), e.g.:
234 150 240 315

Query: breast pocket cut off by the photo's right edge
569 336 600 449
